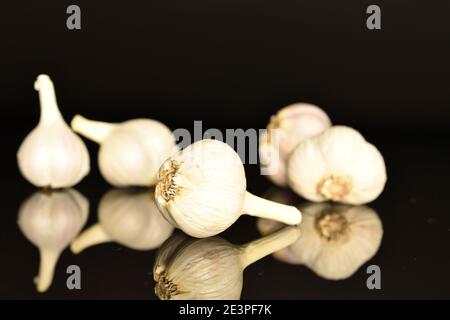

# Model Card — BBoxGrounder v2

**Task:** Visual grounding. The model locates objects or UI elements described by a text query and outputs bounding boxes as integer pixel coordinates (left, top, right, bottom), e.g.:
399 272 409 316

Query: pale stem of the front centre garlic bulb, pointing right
243 192 302 225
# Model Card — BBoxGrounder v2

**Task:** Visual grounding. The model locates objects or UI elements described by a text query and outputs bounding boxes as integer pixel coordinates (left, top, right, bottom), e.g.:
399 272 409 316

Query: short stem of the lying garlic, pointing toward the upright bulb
70 114 115 143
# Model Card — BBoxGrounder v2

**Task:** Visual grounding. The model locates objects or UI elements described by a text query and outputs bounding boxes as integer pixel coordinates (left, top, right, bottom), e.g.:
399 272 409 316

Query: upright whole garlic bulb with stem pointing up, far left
17 75 89 188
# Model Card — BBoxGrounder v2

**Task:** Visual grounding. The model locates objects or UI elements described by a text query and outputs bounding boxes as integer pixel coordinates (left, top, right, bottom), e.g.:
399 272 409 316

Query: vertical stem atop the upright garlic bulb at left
34 74 63 124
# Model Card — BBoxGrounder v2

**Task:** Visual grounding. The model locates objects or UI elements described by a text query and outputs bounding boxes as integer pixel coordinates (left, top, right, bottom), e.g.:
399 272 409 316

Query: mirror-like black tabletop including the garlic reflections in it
0 132 450 299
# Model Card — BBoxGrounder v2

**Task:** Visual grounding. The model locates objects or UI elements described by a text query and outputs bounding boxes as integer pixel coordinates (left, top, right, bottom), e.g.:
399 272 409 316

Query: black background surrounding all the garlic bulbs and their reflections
0 0 450 299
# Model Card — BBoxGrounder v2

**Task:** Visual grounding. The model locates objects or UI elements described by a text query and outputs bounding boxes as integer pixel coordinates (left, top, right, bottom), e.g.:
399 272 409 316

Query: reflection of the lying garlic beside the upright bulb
70 189 173 253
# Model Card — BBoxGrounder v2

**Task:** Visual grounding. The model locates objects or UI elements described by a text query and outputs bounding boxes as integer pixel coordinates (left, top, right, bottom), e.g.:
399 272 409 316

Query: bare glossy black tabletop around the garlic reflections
0 134 450 299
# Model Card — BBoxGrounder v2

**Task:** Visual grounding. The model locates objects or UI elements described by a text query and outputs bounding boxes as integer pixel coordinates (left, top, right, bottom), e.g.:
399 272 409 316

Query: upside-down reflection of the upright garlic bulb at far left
18 189 89 292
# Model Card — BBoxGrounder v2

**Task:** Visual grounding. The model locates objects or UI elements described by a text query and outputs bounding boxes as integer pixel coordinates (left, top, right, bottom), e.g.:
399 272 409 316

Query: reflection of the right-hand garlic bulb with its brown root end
258 203 383 280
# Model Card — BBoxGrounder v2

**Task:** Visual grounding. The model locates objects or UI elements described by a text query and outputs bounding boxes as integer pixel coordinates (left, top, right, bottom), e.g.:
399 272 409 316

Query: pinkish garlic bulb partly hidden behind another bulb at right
259 103 331 187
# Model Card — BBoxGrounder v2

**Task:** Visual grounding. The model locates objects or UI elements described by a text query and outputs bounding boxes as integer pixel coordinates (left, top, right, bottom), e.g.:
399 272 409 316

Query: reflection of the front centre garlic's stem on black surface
241 227 300 269
